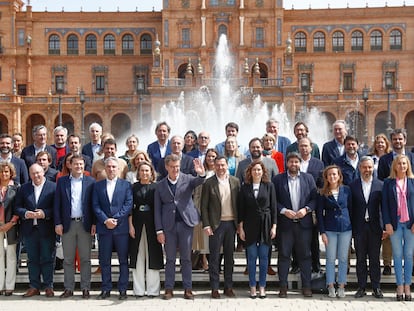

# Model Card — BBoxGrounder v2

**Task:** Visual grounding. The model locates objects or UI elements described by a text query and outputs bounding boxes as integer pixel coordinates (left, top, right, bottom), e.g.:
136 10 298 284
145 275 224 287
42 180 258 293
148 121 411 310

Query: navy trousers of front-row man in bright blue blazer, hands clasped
98 233 129 292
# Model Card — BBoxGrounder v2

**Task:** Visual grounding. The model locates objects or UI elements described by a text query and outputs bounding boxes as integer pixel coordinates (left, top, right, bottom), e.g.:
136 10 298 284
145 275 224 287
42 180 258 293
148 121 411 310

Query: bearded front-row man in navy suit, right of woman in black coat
272 152 316 298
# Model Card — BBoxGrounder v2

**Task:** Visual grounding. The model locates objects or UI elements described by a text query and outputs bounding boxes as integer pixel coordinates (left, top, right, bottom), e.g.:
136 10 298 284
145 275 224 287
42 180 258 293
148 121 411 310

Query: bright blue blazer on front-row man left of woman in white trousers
92 178 132 234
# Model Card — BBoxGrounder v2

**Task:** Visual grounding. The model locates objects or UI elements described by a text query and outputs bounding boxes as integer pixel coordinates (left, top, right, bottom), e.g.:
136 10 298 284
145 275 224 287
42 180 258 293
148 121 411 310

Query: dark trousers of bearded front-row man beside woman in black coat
278 223 312 288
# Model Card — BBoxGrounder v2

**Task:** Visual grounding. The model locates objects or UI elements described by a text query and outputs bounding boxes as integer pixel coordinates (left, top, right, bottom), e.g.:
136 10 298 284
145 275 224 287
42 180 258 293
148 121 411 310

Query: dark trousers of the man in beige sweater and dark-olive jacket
209 221 236 289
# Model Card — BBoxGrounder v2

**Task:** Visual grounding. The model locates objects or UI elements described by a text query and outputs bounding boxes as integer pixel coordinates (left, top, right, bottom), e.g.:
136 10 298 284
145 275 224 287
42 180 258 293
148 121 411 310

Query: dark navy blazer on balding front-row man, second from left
16 180 56 237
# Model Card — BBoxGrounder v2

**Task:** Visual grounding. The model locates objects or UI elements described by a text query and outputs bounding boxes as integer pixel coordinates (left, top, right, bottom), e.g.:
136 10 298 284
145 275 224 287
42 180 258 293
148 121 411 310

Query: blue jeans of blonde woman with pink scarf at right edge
390 222 414 285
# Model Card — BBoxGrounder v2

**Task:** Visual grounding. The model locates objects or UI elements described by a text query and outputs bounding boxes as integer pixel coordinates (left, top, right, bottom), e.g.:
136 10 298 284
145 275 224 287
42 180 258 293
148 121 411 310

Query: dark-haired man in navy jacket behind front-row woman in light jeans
333 136 359 185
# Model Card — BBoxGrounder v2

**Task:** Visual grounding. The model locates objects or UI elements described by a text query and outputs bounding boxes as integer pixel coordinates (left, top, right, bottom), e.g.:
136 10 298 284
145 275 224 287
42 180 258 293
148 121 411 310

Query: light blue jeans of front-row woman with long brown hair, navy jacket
325 230 352 285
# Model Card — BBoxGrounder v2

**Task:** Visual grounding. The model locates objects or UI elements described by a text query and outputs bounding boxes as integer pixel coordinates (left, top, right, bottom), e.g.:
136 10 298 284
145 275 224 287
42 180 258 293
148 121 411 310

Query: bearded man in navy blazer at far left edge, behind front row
0 134 29 184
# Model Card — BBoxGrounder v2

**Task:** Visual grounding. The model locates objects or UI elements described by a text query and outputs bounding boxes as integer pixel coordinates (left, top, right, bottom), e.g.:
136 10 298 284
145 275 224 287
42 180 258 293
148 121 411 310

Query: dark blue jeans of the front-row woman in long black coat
246 243 269 287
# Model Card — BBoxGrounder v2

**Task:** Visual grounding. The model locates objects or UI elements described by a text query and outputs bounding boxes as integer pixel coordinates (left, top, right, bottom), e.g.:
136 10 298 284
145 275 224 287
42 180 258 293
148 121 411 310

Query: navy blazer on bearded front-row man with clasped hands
272 172 316 230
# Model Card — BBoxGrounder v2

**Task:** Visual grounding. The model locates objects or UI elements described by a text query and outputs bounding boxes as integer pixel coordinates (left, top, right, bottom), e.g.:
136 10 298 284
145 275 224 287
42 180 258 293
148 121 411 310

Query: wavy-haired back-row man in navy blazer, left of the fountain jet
147 122 171 170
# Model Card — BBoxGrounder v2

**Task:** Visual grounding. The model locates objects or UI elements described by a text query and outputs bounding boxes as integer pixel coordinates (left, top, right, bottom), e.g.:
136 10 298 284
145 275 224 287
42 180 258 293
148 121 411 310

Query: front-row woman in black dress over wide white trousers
128 161 163 297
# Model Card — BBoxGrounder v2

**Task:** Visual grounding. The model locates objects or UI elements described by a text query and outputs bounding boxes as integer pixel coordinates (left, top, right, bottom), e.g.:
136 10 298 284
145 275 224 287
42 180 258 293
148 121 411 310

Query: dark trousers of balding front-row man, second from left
24 229 56 290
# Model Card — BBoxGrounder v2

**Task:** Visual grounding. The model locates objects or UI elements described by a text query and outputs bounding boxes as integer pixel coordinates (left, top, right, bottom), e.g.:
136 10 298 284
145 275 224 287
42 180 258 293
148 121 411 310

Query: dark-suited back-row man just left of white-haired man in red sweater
20 125 57 168
